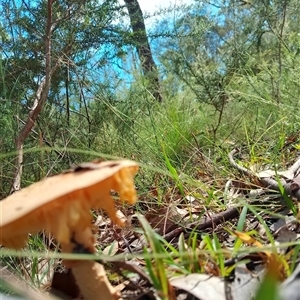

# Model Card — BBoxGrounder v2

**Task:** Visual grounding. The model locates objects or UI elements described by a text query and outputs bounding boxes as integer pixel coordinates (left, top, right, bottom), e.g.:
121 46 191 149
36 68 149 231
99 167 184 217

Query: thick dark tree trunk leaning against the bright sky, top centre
124 0 163 102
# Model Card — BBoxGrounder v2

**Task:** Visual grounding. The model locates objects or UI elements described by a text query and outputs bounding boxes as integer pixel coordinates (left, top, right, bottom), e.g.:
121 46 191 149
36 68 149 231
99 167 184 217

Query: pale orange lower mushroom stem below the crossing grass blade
72 261 121 300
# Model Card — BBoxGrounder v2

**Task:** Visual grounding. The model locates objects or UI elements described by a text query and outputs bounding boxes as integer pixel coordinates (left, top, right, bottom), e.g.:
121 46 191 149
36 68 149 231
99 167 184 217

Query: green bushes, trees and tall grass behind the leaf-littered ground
0 0 300 190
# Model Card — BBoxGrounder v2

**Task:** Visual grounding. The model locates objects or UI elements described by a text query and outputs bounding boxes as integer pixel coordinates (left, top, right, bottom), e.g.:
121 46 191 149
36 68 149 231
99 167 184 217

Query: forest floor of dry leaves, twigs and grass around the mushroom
2 138 300 300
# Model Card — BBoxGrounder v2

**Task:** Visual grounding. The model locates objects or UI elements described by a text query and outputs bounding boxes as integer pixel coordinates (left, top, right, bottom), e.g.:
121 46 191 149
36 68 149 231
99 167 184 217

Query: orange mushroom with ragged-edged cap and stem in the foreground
0 160 138 300
